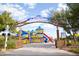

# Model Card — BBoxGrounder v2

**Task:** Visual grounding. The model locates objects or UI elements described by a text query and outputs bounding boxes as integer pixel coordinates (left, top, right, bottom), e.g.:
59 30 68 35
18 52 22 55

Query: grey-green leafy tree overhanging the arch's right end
51 10 71 34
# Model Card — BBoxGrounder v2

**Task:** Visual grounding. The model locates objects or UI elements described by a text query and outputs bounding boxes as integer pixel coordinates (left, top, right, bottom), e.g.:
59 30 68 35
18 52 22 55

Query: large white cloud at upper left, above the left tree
0 4 28 20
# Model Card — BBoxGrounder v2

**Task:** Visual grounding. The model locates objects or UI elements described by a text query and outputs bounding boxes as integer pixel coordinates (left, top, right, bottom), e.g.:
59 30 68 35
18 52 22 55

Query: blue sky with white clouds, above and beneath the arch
0 3 67 38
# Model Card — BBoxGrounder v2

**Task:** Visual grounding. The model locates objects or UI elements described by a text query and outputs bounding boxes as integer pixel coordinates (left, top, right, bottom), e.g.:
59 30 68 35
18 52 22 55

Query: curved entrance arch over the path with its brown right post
16 15 61 40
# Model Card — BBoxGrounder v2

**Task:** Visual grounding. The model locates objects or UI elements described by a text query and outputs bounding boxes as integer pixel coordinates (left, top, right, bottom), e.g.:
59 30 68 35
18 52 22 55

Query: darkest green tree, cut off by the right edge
67 3 79 39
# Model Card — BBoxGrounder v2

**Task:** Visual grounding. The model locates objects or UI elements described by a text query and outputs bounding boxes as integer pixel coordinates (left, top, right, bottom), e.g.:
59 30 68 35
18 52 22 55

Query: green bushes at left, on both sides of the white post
0 36 18 49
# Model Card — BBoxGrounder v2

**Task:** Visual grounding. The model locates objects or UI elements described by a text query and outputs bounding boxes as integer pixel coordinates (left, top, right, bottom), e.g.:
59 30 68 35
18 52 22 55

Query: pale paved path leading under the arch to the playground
0 43 76 56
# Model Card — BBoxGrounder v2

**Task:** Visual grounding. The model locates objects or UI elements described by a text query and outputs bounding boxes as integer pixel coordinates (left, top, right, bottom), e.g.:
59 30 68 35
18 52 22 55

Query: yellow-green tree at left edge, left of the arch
0 11 17 31
